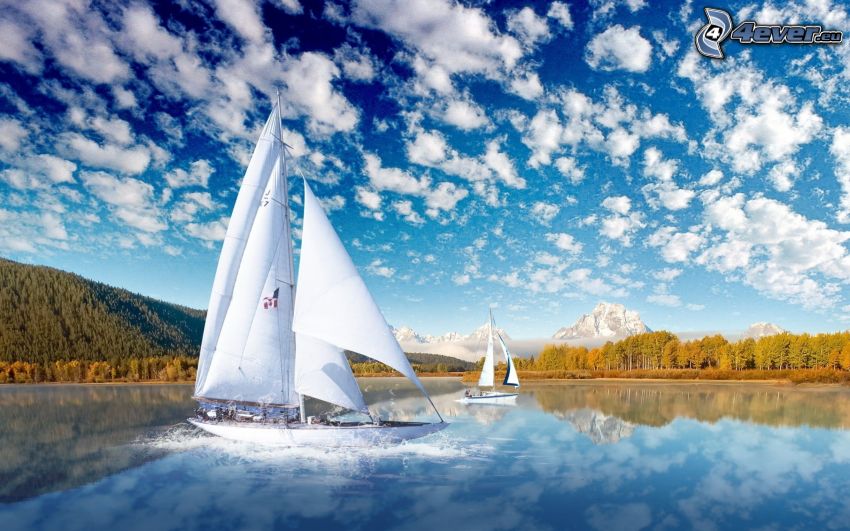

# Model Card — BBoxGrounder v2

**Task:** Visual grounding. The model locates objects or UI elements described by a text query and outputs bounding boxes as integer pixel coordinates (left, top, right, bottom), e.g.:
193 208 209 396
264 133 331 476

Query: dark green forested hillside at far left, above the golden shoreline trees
0 259 205 363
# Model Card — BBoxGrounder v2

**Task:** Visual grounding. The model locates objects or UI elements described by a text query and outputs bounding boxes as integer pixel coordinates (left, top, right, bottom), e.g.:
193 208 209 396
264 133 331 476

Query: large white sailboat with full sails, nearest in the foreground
189 97 446 446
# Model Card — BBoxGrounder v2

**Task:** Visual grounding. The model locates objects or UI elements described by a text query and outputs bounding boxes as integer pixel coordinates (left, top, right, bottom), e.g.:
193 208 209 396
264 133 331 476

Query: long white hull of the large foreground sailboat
188 418 448 447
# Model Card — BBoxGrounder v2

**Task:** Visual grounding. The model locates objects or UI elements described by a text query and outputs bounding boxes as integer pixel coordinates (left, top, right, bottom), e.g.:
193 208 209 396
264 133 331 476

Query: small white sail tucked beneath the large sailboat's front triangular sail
295 334 368 413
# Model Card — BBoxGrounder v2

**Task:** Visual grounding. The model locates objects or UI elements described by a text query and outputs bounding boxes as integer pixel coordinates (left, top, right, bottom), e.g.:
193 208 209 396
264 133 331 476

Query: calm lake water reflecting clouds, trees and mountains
0 378 850 531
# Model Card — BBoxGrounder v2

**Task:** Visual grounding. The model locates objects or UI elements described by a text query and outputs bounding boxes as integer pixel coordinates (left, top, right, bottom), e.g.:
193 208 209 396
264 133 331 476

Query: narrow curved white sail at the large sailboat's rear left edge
195 107 281 394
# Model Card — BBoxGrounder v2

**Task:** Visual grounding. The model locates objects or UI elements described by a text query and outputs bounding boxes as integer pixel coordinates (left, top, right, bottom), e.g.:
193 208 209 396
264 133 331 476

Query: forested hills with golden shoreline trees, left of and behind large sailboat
0 258 473 383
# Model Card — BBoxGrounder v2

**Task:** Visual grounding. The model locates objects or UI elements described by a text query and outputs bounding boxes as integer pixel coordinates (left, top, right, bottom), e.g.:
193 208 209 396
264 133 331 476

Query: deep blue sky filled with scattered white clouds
0 0 850 337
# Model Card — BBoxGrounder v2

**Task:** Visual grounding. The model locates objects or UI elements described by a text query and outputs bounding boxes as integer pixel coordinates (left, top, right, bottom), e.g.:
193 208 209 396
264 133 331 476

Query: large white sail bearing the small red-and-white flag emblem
198 154 298 406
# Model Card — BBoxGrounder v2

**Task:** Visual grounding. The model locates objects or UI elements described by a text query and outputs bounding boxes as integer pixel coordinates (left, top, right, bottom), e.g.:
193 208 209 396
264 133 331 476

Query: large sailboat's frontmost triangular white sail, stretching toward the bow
292 181 427 396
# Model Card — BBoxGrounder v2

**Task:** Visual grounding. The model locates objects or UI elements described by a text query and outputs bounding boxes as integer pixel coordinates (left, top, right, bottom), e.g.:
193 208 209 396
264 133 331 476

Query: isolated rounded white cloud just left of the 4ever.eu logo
585 24 652 72
